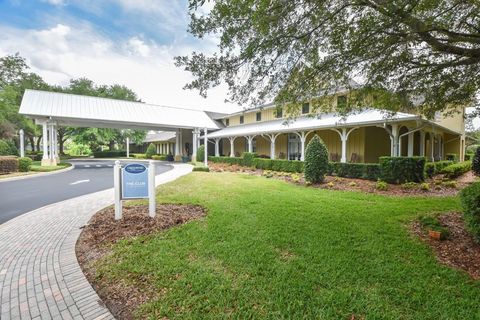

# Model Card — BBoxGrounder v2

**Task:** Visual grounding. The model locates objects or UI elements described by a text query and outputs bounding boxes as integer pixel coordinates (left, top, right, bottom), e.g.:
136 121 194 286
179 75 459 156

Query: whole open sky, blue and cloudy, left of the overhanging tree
0 0 241 113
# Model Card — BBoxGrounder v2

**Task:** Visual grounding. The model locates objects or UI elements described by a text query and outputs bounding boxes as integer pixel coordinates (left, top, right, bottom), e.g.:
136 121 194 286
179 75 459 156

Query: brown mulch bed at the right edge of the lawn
412 212 480 279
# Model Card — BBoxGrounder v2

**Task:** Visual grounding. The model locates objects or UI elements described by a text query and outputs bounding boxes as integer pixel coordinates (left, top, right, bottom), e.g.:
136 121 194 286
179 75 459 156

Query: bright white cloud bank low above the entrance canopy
0 24 239 112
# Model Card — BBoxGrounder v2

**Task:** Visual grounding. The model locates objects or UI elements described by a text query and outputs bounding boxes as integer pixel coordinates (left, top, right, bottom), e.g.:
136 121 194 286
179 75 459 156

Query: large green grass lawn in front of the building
99 173 480 319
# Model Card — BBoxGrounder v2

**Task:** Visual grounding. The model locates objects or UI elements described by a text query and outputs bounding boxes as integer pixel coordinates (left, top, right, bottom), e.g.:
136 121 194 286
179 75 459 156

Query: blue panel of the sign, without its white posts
121 163 148 199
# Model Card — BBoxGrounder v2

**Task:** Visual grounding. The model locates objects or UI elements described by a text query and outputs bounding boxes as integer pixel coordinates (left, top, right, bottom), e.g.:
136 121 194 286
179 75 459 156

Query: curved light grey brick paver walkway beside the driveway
0 164 192 320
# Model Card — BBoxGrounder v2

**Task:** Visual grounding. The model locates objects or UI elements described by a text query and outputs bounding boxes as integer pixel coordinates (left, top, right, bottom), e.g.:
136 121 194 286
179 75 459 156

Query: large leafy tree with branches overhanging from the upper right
176 0 480 116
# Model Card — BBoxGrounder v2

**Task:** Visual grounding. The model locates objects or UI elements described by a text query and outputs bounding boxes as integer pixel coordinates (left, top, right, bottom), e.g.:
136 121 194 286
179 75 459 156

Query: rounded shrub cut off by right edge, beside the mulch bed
460 182 480 242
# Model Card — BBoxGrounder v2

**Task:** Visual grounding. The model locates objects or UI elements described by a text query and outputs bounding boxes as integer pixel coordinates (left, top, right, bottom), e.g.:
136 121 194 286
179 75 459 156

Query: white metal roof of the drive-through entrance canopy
19 90 219 130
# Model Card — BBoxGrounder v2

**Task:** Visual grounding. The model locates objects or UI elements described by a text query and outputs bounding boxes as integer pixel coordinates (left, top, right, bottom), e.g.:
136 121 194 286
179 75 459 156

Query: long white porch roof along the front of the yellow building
208 109 421 138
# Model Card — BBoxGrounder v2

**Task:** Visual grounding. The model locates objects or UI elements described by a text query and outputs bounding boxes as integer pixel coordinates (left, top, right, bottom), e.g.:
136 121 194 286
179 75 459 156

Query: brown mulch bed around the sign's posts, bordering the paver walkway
76 204 206 319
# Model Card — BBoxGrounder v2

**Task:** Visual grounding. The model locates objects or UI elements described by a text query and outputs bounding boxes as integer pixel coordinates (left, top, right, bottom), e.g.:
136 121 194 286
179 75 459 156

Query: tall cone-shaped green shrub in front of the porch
304 135 329 183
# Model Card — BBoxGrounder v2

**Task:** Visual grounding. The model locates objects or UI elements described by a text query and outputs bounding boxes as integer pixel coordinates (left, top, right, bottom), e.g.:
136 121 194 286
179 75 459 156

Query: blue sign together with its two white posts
113 160 156 220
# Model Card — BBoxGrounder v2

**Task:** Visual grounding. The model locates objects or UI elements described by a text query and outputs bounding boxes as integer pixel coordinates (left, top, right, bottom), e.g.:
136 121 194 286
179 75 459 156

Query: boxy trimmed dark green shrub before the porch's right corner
380 157 425 183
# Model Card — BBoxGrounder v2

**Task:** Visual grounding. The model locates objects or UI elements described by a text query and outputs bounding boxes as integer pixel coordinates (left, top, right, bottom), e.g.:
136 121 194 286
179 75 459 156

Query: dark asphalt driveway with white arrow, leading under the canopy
0 160 171 224
